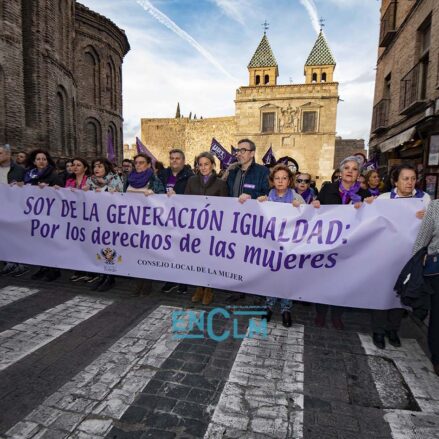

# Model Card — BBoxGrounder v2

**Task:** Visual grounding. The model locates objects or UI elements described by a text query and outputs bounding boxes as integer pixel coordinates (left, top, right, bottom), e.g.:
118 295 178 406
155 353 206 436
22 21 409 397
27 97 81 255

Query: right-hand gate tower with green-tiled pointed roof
304 29 335 84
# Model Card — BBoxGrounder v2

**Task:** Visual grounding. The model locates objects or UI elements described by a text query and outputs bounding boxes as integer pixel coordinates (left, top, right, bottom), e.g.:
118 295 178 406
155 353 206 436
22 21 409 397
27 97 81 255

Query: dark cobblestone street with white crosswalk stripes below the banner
0 272 439 439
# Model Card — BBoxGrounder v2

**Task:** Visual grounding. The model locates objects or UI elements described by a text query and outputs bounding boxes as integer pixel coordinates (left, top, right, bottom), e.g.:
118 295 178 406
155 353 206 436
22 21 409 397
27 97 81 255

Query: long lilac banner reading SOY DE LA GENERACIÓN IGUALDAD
0 185 422 309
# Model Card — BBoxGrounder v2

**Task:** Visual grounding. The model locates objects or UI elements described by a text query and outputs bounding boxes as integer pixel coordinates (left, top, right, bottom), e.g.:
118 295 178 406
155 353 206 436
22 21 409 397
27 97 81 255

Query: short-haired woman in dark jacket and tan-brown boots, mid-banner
184 152 229 306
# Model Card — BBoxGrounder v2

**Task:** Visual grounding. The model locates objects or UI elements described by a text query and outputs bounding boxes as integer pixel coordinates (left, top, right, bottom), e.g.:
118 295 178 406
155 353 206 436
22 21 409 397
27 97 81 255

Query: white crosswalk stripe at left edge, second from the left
0 296 113 371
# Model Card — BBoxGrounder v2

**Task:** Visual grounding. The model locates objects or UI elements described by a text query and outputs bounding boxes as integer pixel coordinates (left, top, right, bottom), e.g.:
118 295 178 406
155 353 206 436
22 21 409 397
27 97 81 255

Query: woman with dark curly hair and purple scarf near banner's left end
24 149 63 282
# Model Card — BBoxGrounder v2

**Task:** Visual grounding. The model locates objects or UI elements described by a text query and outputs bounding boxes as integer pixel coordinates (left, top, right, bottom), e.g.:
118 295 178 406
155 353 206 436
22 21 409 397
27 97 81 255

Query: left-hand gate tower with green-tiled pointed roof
247 32 279 87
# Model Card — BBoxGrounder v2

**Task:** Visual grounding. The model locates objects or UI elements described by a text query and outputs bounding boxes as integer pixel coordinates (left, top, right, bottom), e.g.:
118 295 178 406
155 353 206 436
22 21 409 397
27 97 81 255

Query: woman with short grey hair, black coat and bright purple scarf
315 156 370 330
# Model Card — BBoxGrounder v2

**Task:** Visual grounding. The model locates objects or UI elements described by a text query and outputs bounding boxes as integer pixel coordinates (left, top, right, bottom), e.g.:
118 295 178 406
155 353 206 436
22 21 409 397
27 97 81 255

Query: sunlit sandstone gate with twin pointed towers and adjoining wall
141 32 338 181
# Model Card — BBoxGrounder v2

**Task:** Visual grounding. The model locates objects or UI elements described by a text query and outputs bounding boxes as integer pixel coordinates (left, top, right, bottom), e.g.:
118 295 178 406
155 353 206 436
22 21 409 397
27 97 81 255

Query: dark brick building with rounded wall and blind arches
0 0 130 163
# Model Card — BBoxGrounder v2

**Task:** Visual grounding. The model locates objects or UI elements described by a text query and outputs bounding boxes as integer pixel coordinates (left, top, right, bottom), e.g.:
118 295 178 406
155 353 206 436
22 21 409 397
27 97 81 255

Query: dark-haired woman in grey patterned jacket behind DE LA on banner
83 157 123 292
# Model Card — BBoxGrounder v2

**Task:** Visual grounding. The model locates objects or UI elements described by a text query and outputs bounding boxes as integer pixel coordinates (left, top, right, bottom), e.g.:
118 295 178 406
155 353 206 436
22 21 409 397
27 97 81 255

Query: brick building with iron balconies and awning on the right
370 0 439 195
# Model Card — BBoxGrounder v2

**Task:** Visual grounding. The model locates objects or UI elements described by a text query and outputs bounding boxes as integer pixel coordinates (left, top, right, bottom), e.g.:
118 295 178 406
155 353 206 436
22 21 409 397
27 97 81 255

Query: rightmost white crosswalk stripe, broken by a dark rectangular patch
358 334 439 439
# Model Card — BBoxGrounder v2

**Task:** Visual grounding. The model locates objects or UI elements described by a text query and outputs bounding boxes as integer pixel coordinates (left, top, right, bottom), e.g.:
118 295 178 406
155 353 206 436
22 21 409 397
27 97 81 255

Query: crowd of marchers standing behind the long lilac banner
0 139 439 375
